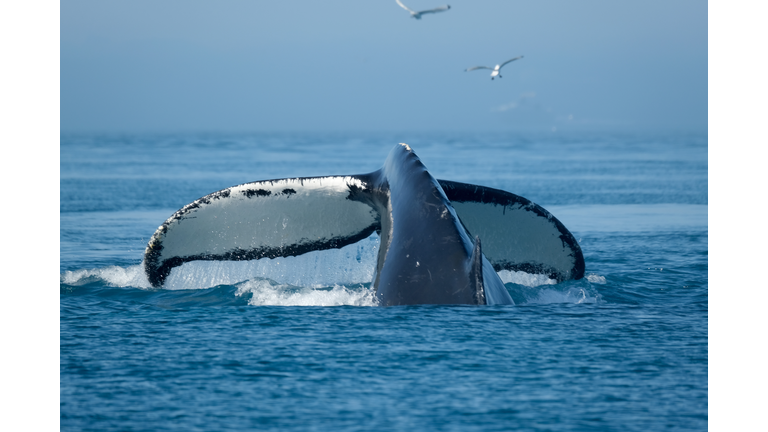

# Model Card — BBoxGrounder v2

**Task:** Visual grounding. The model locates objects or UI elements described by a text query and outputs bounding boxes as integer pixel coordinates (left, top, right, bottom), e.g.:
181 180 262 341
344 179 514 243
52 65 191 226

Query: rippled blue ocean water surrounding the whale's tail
60 133 708 431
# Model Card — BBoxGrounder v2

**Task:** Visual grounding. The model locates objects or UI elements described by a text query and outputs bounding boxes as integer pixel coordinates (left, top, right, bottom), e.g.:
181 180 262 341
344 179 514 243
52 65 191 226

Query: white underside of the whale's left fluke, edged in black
150 176 377 263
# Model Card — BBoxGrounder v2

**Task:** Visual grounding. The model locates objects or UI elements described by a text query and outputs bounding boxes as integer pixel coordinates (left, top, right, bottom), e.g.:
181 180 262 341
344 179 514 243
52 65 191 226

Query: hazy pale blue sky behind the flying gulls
60 0 707 132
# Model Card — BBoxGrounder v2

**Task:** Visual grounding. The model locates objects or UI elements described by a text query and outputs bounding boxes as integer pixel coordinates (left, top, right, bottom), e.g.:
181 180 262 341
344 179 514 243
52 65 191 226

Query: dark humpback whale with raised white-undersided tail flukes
144 144 584 306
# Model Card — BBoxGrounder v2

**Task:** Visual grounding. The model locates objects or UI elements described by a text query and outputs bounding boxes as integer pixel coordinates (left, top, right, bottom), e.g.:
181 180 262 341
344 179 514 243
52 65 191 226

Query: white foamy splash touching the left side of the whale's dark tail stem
235 279 377 306
